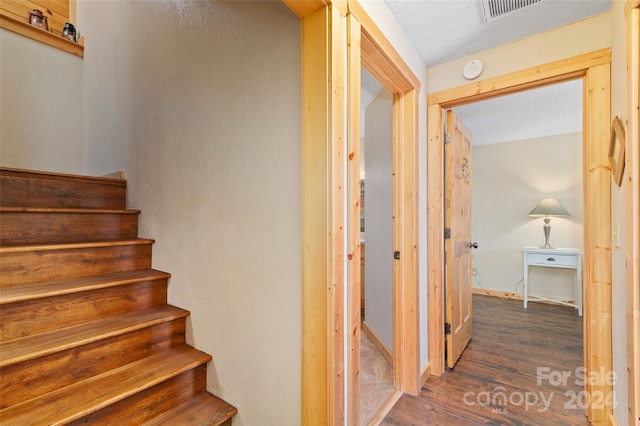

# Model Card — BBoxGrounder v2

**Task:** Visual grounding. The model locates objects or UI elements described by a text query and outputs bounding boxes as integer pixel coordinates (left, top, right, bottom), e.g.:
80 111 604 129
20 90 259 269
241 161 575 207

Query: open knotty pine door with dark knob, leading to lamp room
444 110 477 368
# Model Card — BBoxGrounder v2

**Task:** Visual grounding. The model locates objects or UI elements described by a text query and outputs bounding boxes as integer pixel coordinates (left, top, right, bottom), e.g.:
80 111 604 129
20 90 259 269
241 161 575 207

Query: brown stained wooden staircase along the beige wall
0 168 237 426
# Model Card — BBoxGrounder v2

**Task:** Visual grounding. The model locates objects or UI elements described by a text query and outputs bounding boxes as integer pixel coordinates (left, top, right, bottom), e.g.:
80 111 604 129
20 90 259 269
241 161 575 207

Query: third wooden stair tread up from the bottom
0 305 189 367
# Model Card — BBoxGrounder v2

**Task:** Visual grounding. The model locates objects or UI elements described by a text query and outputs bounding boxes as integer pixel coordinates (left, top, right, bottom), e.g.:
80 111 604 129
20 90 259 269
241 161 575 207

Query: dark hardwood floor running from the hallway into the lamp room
382 295 597 426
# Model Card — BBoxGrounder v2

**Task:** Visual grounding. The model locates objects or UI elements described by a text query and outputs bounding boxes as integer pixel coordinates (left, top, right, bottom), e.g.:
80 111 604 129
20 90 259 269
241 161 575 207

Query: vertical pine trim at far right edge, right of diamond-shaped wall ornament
624 0 640 425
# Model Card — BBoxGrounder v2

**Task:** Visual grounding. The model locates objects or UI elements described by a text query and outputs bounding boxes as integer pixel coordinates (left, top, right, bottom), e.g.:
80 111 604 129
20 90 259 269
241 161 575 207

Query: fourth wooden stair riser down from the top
0 279 167 342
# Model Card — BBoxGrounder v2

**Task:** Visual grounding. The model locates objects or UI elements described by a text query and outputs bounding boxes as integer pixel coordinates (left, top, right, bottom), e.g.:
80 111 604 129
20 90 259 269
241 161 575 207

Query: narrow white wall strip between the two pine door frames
360 0 429 371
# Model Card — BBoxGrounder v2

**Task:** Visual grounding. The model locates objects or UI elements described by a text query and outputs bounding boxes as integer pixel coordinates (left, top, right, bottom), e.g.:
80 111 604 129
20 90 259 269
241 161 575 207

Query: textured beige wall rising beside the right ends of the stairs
78 0 301 425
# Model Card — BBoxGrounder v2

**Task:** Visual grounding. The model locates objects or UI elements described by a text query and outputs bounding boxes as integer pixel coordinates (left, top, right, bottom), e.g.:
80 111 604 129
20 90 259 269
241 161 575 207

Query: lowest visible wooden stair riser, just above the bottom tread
65 365 207 426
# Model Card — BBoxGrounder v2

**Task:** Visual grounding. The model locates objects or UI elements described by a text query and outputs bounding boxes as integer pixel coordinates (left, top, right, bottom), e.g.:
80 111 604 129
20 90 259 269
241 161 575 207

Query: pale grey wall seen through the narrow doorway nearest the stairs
364 88 393 353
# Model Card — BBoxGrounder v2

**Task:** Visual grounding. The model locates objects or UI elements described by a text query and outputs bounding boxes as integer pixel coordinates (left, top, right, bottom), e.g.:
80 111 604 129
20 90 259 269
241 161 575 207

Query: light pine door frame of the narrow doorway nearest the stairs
283 0 420 425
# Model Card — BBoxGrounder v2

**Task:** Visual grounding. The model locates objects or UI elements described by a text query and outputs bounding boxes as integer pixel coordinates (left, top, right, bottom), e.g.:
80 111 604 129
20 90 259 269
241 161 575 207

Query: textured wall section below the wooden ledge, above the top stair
0 29 84 174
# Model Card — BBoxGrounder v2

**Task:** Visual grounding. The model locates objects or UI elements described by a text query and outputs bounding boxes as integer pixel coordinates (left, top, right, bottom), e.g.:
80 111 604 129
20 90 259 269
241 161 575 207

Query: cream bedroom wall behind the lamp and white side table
471 133 583 300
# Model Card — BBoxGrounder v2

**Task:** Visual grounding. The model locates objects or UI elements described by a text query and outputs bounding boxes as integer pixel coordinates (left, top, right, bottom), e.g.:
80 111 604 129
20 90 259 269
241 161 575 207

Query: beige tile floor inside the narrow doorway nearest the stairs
360 333 394 425
